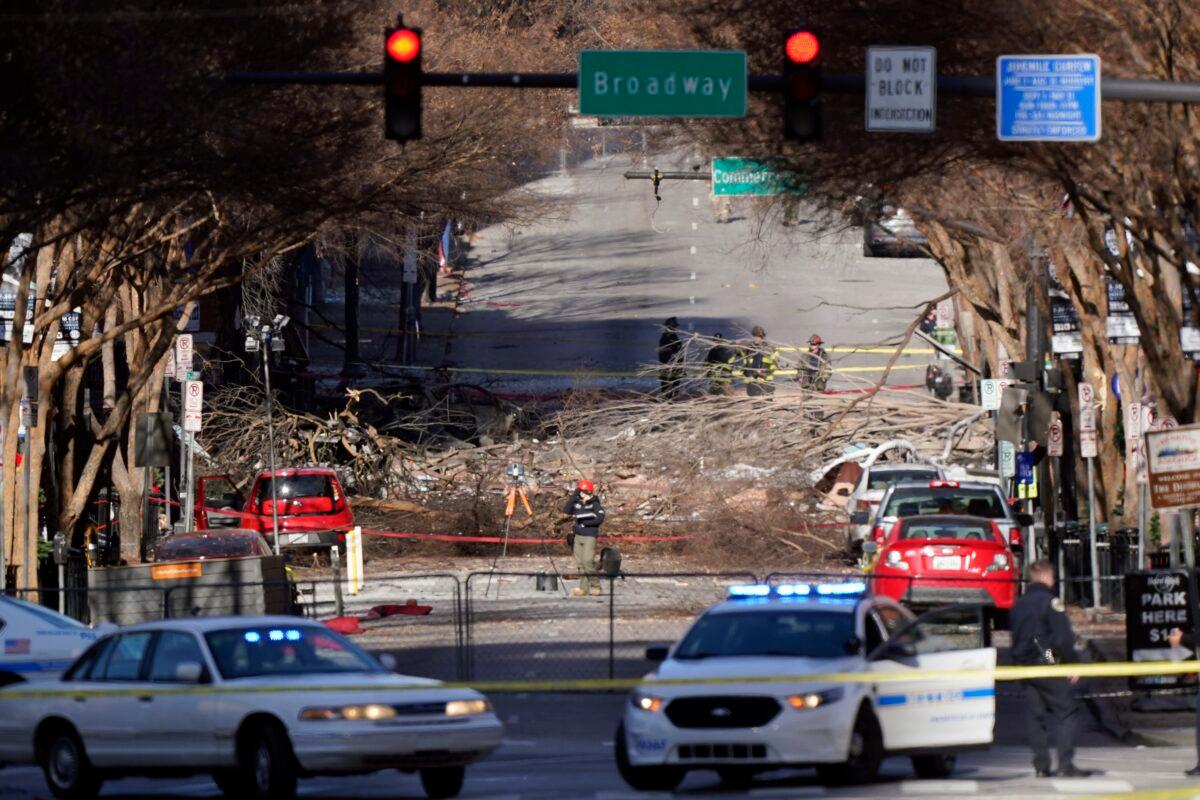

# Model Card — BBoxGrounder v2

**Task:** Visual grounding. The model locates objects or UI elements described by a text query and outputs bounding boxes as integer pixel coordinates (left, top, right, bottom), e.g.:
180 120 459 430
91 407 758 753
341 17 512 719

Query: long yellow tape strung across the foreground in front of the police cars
0 661 1200 700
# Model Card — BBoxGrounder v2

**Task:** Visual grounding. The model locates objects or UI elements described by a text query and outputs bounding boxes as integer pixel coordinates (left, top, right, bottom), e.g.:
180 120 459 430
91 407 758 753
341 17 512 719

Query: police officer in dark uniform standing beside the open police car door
1012 561 1094 777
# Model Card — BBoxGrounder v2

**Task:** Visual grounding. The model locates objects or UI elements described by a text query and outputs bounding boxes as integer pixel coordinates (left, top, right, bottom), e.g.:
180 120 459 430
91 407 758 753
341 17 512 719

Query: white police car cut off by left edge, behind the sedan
0 595 101 686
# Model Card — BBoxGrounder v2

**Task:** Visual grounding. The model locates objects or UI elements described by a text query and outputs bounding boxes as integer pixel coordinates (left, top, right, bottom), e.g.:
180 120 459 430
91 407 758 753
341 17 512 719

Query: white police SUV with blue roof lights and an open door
614 582 996 790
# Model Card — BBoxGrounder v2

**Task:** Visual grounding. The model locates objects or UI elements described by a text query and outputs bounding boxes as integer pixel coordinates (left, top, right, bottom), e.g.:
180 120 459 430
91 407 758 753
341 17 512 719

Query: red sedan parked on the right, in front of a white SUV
870 515 1018 609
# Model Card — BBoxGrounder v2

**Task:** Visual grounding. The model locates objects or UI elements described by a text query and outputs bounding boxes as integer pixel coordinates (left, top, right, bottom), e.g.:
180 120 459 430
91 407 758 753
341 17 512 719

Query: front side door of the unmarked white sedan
138 631 217 766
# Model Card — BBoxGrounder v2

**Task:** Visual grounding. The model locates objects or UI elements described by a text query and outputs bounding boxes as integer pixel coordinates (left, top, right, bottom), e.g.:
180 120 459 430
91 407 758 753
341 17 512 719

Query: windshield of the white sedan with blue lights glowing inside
204 625 385 680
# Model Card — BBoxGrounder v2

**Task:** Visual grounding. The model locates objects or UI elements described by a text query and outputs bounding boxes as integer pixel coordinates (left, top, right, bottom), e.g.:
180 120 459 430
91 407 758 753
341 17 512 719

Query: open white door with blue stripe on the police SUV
868 604 996 751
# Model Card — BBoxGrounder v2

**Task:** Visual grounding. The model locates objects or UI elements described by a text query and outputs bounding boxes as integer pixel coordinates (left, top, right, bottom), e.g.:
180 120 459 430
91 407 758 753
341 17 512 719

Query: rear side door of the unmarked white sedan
70 631 154 769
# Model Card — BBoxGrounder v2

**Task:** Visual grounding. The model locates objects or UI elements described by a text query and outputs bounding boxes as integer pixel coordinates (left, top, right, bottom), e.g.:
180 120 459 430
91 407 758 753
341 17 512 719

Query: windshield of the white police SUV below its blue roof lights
673 609 854 660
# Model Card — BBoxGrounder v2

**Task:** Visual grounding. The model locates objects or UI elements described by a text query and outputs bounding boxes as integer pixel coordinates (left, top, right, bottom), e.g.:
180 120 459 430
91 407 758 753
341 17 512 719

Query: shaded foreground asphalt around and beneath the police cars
0 693 1200 800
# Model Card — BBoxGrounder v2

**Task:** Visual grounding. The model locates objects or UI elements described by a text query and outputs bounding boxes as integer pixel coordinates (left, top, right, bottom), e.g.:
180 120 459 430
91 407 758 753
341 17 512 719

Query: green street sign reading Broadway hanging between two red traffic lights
580 50 746 116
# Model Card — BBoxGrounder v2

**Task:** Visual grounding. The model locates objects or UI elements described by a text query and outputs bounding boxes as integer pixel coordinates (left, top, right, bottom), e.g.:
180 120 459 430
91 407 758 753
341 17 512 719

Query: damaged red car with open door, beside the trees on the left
196 467 354 547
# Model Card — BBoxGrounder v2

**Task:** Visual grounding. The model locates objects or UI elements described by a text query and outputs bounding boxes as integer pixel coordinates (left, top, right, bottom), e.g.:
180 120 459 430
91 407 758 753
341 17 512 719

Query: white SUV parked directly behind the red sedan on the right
871 481 1033 554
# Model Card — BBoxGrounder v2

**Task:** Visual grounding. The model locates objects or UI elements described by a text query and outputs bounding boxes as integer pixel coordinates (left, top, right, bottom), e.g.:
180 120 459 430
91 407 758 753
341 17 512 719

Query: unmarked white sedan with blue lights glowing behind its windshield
0 616 503 800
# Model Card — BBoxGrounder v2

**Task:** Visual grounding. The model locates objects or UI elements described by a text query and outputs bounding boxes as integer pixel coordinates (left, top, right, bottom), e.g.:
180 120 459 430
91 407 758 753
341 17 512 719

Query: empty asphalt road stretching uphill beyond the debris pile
310 146 946 393
